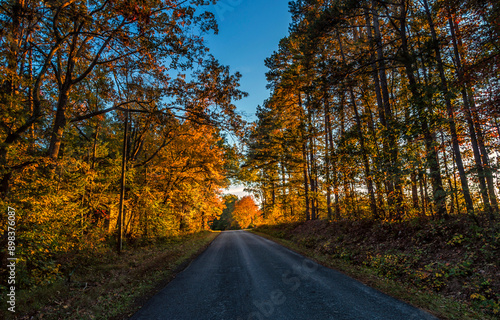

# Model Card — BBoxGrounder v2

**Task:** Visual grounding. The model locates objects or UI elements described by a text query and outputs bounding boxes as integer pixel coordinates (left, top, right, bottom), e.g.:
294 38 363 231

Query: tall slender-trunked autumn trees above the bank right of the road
242 0 500 223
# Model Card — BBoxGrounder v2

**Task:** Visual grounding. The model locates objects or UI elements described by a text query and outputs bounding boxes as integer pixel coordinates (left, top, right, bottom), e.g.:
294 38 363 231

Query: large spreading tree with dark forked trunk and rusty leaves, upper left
0 0 242 194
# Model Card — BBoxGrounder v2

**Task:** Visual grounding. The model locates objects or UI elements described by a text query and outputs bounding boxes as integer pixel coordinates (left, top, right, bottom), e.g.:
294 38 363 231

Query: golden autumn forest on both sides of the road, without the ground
0 0 500 318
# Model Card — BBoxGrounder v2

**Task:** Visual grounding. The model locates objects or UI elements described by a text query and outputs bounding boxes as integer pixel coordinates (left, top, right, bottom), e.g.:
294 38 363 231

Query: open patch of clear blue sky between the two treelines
205 0 291 121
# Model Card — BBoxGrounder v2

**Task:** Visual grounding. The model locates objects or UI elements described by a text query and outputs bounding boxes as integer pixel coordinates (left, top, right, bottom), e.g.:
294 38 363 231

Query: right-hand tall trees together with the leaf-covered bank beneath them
240 0 500 319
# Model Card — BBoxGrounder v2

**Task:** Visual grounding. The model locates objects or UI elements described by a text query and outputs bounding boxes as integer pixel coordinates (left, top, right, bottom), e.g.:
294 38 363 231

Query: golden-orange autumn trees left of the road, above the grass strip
0 0 246 288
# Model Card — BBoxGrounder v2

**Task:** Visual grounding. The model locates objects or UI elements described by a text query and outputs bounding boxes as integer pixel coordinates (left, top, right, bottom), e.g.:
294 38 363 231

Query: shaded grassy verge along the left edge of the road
0 232 218 319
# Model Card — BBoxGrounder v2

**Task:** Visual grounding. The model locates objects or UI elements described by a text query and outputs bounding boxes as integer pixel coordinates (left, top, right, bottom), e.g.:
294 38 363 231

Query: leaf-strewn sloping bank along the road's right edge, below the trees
255 219 500 320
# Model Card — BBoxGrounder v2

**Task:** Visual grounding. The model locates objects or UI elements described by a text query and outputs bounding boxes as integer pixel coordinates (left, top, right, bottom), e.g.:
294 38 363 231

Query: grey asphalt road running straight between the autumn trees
131 231 437 320
